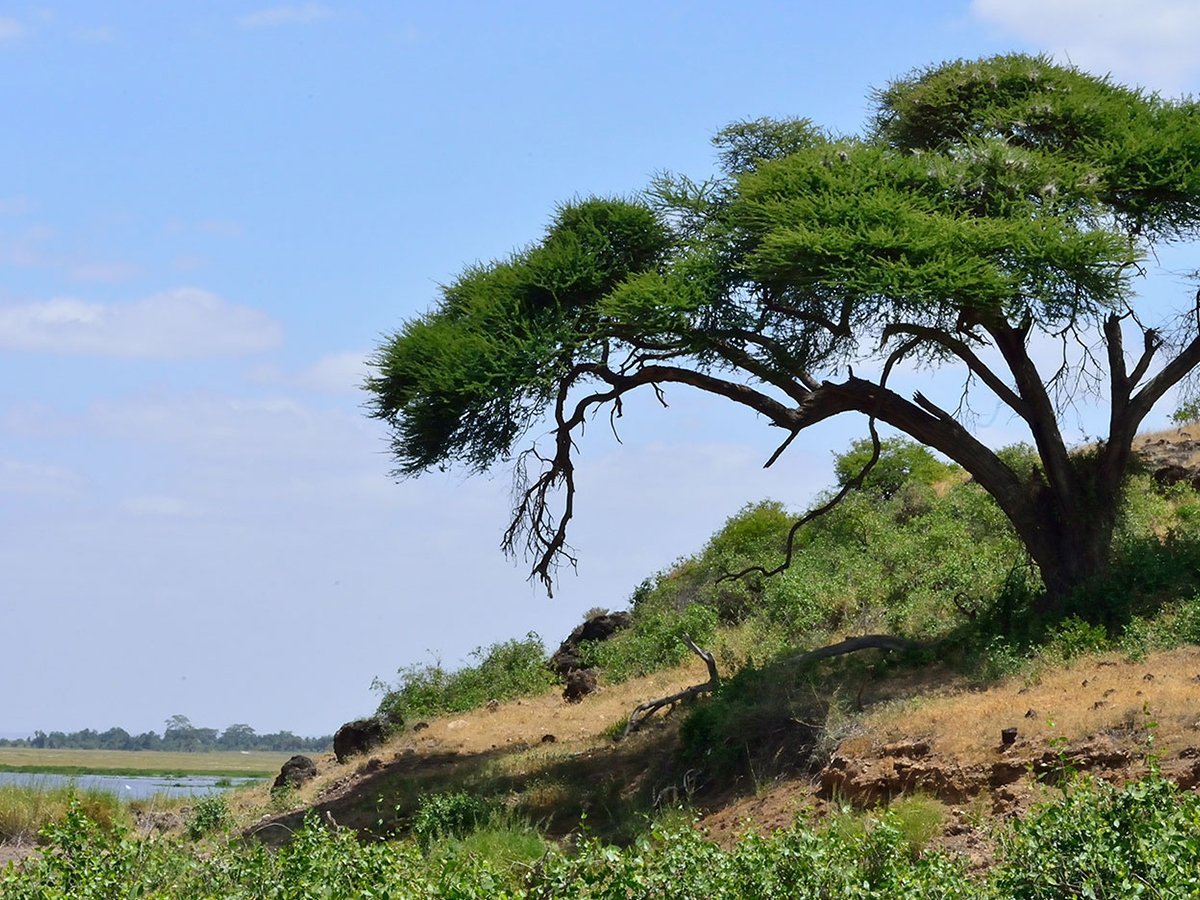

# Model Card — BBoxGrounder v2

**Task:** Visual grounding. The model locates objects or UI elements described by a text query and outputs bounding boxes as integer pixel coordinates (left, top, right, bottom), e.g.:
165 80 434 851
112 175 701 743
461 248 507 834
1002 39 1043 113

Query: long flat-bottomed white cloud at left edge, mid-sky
0 288 282 359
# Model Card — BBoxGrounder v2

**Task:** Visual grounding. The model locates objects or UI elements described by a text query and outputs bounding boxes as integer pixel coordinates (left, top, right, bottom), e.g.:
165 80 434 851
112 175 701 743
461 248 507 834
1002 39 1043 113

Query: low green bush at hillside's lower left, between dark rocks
372 631 554 722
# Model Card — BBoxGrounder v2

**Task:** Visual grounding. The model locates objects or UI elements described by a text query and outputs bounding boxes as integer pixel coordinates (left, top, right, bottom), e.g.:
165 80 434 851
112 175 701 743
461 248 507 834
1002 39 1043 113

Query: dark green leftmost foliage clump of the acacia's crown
366 198 668 475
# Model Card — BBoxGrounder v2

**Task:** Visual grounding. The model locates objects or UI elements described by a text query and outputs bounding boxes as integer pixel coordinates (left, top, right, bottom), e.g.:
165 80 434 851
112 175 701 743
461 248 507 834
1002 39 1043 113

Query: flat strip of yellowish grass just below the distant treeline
0 746 292 776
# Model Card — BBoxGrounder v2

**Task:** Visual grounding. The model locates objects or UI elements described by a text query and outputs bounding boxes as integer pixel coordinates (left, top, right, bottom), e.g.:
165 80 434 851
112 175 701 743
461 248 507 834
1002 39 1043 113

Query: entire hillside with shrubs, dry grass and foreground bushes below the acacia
7 428 1200 898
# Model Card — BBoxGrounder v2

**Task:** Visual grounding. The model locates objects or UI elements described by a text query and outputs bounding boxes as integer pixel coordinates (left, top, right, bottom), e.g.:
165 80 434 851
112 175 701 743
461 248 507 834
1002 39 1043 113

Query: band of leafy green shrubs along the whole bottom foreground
7 775 1200 900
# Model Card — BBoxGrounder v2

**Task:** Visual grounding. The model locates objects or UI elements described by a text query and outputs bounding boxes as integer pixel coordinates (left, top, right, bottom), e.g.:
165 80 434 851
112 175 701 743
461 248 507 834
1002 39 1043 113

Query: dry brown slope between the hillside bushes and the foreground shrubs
241 430 1200 865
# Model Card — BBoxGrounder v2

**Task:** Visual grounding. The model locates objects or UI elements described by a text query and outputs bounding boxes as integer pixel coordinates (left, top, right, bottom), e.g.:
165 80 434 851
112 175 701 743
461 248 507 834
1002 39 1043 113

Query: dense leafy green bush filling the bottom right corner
996 775 1200 900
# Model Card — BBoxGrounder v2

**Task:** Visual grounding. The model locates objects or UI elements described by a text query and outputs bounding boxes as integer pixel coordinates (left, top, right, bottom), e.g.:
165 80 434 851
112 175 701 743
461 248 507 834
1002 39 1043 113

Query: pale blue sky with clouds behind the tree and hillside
0 0 1200 734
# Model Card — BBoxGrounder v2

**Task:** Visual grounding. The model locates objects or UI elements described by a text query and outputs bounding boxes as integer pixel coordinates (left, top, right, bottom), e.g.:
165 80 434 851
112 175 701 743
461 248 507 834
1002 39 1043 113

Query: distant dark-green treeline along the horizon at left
0 715 334 752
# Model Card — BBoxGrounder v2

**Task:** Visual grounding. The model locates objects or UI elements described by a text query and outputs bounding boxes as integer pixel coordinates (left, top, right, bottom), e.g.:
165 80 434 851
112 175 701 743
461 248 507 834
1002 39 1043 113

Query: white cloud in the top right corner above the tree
971 0 1200 95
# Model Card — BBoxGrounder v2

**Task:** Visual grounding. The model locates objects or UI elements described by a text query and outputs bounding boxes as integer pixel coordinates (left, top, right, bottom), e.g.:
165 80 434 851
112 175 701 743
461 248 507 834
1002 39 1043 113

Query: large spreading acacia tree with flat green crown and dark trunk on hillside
367 55 1200 607
